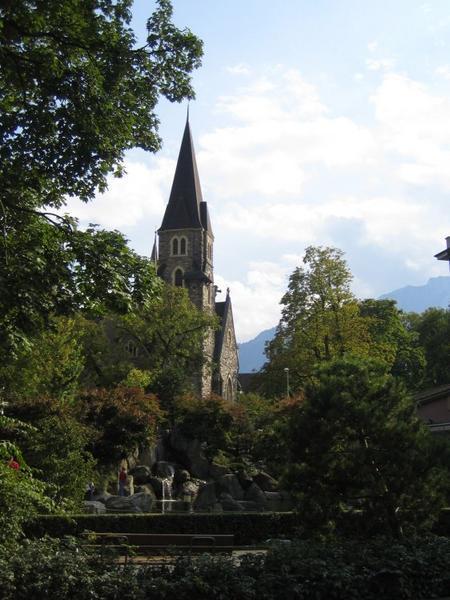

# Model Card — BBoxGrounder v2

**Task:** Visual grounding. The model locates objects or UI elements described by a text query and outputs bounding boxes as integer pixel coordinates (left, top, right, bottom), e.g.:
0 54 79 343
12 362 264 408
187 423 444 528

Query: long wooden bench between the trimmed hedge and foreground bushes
83 532 234 564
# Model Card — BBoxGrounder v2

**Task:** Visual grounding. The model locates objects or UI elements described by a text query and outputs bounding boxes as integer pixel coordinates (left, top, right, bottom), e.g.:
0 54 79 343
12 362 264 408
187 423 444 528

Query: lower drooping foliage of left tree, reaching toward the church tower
0 220 160 363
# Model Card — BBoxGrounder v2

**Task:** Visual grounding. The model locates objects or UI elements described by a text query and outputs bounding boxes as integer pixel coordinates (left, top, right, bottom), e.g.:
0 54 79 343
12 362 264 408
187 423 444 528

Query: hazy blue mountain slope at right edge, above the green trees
380 277 450 312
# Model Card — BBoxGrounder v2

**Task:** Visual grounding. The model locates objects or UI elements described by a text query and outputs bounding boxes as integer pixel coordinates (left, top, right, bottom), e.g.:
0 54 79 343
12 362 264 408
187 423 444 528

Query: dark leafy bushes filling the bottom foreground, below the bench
0 537 450 600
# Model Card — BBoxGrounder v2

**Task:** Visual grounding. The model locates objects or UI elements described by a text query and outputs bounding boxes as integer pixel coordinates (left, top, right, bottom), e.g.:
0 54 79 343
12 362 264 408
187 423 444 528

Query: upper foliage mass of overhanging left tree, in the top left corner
0 0 202 207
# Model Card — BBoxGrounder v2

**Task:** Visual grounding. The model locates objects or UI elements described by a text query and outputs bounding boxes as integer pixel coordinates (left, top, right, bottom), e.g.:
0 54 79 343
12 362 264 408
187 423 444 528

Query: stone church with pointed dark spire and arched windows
152 119 239 402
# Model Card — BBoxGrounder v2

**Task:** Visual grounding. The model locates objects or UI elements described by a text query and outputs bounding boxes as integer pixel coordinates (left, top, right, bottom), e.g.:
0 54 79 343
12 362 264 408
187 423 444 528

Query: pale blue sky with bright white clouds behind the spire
65 0 450 342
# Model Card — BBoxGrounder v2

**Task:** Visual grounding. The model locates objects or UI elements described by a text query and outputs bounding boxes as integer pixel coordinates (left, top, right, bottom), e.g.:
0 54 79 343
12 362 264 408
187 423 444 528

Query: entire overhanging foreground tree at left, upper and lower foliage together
0 0 202 360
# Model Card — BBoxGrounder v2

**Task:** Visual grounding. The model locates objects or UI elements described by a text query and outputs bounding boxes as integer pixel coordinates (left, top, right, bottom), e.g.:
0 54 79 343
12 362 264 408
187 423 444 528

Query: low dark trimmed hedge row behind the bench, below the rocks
25 508 450 545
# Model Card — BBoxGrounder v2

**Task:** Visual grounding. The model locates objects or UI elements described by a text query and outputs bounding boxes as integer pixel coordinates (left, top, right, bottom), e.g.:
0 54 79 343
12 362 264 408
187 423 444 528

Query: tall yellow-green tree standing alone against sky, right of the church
263 246 370 394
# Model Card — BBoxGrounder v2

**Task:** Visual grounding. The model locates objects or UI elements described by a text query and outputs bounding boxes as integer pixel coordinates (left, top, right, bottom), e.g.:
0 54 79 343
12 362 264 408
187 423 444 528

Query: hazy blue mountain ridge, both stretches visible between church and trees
239 276 450 373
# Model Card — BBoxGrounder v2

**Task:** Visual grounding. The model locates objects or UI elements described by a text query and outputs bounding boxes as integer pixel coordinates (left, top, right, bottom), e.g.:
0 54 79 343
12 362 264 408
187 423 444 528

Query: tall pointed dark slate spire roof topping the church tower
160 121 203 231
